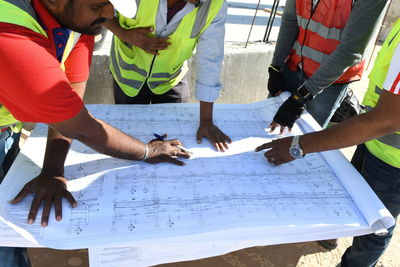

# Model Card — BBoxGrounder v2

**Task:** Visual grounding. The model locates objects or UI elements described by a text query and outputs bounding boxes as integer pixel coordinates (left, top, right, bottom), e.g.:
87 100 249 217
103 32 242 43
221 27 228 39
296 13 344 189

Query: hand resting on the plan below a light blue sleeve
197 121 232 152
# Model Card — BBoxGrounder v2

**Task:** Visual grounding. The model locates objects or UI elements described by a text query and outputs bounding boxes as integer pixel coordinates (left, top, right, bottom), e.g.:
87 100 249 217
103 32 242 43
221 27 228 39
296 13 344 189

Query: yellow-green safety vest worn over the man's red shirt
0 0 80 131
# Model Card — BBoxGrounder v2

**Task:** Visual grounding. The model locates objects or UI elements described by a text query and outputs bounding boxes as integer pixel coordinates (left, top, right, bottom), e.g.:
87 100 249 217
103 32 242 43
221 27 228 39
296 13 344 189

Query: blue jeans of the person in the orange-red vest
283 66 349 128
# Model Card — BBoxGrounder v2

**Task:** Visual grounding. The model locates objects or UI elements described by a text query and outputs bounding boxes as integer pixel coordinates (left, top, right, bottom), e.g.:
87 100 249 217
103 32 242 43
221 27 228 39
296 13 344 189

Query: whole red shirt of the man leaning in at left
0 0 94 123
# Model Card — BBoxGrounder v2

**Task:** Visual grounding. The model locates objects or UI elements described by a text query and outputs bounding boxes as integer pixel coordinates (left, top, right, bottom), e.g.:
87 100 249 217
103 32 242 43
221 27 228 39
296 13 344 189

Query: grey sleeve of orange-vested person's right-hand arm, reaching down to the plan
305 0 387 95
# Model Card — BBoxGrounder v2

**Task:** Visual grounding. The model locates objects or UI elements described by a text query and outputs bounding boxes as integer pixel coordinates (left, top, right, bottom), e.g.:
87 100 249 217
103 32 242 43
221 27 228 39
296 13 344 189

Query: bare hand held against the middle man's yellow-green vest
118 27 170 55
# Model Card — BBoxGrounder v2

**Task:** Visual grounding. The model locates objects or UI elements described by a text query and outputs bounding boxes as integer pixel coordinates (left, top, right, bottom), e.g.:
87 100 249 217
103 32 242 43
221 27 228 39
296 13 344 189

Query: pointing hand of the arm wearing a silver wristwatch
255 137 294 166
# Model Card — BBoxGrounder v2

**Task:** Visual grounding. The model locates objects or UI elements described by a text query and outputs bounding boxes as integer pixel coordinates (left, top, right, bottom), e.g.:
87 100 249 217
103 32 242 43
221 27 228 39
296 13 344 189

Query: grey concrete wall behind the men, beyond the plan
85 37 274 104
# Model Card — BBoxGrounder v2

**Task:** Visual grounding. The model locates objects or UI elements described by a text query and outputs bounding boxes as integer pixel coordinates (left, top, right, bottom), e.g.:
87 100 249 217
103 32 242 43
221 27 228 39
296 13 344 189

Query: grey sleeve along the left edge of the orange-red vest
272 0 299 66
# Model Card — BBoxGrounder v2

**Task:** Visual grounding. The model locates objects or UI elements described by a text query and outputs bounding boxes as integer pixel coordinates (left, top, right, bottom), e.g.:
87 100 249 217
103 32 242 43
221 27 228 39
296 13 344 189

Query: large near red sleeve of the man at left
0 23 83 123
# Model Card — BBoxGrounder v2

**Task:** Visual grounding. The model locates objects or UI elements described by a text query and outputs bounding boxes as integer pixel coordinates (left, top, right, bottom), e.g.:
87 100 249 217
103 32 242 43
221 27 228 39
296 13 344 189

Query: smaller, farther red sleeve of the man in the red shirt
65 34 94 82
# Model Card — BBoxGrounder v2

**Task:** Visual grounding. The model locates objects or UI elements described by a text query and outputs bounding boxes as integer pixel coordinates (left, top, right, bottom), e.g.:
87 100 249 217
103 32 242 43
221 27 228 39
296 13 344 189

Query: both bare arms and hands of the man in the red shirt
11 83 189 227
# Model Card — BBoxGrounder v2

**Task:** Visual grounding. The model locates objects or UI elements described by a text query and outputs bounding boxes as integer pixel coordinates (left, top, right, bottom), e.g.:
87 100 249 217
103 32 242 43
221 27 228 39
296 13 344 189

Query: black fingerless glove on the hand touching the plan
274 96 305 128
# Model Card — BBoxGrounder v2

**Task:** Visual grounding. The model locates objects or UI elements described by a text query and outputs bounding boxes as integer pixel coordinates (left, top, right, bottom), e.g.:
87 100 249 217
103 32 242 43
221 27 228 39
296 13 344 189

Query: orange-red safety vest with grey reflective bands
286 0 365 83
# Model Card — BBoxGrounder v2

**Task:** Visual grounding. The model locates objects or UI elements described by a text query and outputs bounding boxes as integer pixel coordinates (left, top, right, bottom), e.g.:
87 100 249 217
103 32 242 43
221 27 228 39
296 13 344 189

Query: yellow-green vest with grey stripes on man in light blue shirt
110 0 223 97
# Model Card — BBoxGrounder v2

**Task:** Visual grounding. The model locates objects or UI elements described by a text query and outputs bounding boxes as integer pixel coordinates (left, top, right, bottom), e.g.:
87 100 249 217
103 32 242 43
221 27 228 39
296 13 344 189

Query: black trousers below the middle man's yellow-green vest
113 76 190 104
